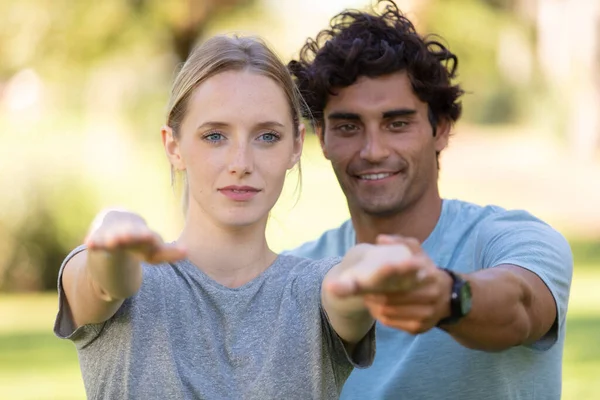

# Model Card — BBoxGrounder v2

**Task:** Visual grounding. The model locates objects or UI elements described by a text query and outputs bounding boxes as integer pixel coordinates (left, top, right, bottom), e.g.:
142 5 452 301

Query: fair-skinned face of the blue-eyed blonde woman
165 71 304 227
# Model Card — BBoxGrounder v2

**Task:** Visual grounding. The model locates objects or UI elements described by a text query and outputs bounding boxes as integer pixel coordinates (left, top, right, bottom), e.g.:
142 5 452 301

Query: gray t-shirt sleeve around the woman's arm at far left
54 245 106 349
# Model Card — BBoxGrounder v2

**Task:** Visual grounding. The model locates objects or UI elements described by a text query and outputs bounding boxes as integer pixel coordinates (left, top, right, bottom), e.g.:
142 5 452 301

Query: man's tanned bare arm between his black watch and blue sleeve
442 266 556 351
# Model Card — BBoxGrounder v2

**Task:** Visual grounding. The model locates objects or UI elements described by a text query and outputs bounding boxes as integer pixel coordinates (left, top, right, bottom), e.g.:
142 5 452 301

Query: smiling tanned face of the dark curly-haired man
319 71 450 216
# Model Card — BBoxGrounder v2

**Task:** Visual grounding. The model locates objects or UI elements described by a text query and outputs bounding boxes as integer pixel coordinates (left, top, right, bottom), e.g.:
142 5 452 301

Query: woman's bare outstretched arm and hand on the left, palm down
61 210 186 327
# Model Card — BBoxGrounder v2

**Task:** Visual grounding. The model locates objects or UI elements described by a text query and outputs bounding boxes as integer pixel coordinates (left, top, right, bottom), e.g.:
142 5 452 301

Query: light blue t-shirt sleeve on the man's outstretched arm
475 211 573 350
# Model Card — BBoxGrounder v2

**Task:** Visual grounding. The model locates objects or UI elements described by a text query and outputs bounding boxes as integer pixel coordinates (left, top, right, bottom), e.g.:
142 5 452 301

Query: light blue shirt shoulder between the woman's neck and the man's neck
284 220 356 260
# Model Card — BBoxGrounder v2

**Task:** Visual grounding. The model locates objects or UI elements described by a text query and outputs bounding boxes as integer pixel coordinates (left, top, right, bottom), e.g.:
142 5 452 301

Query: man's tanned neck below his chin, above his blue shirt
350 194 442 243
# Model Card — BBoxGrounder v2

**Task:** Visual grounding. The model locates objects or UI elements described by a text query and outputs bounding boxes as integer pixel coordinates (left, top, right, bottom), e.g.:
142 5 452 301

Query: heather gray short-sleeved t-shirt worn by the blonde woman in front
54 247 375 400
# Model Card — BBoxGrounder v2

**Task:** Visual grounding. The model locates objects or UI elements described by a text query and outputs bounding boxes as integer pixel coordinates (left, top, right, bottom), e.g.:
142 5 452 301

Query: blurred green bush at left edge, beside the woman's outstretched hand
0 178 96 291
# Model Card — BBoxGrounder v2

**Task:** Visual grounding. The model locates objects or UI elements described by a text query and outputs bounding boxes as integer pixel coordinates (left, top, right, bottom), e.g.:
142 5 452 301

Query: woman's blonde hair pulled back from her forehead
167 35 303 210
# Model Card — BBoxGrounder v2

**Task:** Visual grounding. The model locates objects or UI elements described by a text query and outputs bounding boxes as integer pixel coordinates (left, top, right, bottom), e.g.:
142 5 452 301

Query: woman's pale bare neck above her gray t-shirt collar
177 207 277 287
